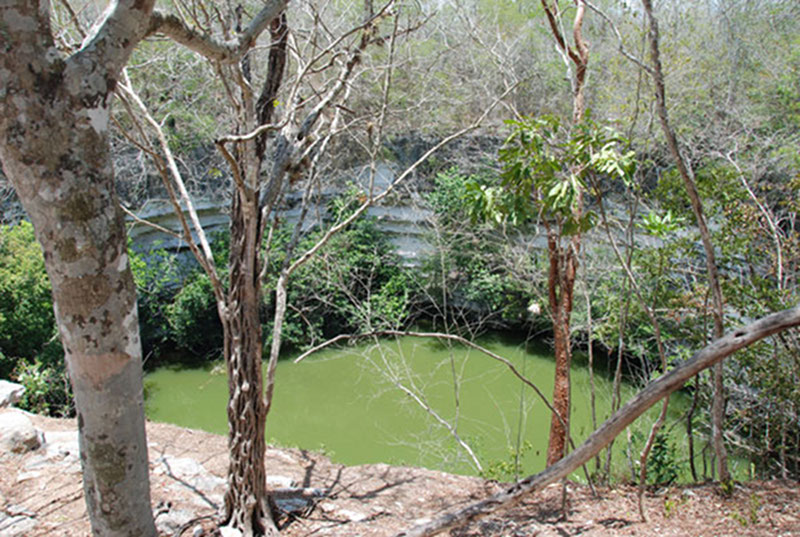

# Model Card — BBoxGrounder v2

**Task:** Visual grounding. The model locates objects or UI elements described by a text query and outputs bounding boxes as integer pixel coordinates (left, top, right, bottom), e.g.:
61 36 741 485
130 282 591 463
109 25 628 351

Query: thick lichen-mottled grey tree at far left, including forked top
0 0 156 537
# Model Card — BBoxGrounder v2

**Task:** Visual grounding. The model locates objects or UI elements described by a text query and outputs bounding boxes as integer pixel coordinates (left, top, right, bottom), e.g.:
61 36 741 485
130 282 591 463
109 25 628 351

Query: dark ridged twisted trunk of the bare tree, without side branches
220 13 287 536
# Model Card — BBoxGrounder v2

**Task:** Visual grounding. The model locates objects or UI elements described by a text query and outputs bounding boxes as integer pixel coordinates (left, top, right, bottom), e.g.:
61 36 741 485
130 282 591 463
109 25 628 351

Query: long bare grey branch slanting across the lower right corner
396 305 800 537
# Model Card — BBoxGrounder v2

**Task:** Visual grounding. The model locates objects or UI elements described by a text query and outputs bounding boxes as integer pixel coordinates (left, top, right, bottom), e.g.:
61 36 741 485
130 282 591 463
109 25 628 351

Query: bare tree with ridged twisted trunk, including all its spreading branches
120 0 506 535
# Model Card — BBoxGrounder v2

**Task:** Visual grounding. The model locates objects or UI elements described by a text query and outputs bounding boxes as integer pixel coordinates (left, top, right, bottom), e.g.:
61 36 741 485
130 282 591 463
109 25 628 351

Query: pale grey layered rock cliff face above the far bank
117 133 502 265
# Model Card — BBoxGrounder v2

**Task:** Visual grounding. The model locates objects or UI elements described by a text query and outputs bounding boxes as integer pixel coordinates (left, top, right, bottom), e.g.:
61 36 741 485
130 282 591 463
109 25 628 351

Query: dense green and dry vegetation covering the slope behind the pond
0 0 800 488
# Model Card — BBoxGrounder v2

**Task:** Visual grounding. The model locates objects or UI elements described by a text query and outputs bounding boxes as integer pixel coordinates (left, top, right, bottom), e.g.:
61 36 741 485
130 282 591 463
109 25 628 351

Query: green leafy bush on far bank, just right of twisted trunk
265 187 413 348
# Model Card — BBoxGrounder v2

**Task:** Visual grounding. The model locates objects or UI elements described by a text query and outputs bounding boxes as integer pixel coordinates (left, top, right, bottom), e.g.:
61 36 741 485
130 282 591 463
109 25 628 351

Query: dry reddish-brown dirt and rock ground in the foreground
0 408 800 537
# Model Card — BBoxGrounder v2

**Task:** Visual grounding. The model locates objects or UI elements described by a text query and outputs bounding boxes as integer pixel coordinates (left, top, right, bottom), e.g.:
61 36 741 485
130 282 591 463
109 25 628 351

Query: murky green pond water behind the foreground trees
145 336 704 475
